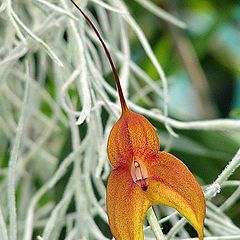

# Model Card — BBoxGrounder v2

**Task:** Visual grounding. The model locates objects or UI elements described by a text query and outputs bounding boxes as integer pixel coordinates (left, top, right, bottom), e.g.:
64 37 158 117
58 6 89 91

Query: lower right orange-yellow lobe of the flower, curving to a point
146 152 206 240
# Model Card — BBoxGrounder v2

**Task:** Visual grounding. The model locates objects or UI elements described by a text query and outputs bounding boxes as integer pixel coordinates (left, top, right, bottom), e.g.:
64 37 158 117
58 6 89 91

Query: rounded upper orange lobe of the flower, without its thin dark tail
108 111 159 168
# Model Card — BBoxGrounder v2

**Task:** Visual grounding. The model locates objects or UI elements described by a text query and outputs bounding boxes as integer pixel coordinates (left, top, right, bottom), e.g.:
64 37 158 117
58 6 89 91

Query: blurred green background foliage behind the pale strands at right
126 0 240 226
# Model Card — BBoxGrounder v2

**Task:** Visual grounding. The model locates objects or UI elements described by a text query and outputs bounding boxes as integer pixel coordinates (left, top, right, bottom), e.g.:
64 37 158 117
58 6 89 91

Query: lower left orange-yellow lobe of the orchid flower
107 167 150 240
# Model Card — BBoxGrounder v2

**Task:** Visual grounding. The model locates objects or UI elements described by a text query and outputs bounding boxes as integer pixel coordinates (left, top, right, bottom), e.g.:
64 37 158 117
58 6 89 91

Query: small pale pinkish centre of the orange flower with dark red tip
131 160 149 192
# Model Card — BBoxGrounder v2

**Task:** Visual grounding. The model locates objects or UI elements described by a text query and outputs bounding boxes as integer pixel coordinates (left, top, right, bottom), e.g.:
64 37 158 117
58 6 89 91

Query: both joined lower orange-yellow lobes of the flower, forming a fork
107 152 205 240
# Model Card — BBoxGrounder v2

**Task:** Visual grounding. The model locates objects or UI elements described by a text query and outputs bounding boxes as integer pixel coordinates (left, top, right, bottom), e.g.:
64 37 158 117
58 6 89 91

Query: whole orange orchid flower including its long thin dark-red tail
71 0 206 240
